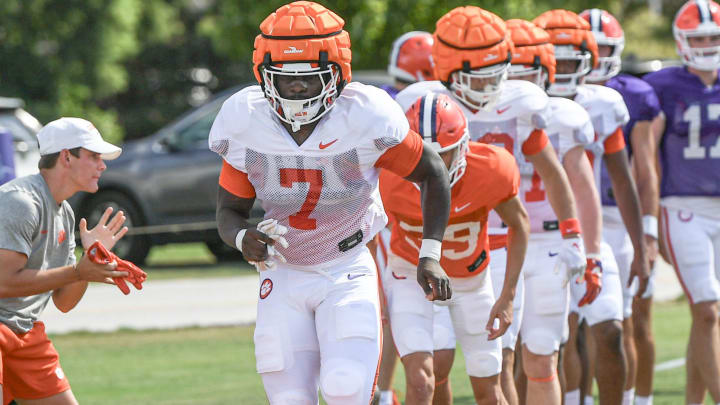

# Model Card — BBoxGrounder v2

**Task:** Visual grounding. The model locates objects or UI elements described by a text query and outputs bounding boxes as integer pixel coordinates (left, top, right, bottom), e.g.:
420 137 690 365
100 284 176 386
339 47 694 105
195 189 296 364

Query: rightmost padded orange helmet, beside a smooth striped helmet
533 9 598 97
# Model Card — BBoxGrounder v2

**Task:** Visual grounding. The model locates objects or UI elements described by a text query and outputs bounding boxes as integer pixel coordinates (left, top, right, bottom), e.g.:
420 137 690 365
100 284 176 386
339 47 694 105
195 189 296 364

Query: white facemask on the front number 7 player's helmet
262 62 340 132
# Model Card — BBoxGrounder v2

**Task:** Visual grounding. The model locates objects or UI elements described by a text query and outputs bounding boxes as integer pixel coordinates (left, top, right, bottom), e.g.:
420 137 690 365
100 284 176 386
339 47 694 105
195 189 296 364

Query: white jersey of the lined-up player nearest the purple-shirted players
575 84 630 188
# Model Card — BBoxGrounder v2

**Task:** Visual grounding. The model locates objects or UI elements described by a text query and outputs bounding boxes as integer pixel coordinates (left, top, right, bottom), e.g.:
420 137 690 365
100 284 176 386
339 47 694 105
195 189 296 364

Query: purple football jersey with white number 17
644 66 720 197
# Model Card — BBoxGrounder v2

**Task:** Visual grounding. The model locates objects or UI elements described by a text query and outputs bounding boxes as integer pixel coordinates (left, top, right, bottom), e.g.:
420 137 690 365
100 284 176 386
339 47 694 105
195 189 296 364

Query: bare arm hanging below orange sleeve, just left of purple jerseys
604 150 645 258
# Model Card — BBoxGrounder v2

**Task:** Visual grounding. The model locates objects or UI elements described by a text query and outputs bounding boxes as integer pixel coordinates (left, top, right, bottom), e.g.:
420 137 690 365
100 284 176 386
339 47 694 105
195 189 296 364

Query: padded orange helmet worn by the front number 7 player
253 1 352 131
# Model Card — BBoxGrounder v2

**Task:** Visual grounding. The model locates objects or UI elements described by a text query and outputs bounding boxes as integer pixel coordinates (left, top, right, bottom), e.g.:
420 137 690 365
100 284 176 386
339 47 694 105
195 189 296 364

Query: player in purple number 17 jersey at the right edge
644 0 720 404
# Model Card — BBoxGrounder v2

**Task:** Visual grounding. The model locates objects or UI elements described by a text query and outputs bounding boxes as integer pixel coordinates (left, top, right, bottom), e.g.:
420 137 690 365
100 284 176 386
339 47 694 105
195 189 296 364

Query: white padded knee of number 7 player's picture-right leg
320 359 372 404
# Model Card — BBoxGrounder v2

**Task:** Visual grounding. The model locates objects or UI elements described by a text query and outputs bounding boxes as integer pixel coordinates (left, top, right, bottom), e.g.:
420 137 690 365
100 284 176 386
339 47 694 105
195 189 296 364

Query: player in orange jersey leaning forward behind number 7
380 93 529 405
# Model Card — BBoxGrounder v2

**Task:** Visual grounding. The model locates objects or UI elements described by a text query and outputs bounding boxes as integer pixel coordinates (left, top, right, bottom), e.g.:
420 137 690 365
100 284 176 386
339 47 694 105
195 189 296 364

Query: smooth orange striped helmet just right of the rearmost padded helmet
580 8 625 83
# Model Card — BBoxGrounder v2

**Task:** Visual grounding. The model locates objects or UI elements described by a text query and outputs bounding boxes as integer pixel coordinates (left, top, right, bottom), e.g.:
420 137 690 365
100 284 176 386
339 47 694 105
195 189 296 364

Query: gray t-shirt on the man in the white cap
0 174 75 333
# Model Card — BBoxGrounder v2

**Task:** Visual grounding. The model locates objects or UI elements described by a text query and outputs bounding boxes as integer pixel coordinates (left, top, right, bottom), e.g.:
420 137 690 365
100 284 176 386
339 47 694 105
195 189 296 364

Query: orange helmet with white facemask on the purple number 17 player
673 0 720 70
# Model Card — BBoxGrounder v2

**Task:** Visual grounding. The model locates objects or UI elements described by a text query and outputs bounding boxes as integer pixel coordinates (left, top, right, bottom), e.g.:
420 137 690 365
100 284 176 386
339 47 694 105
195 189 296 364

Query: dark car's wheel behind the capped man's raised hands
83 191 151 264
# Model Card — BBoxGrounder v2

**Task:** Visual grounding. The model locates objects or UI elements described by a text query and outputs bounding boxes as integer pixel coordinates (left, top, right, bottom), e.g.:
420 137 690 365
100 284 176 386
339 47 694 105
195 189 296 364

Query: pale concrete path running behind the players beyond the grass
40 262 682 334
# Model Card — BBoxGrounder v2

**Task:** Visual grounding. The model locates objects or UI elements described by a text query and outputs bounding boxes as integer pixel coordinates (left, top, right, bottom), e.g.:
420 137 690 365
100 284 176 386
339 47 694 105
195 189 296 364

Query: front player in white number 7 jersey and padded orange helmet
209 1 451 405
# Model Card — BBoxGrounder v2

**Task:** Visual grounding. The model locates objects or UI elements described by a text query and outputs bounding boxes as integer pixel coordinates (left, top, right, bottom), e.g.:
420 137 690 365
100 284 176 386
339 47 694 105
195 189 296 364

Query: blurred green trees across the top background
0 0 684 143
